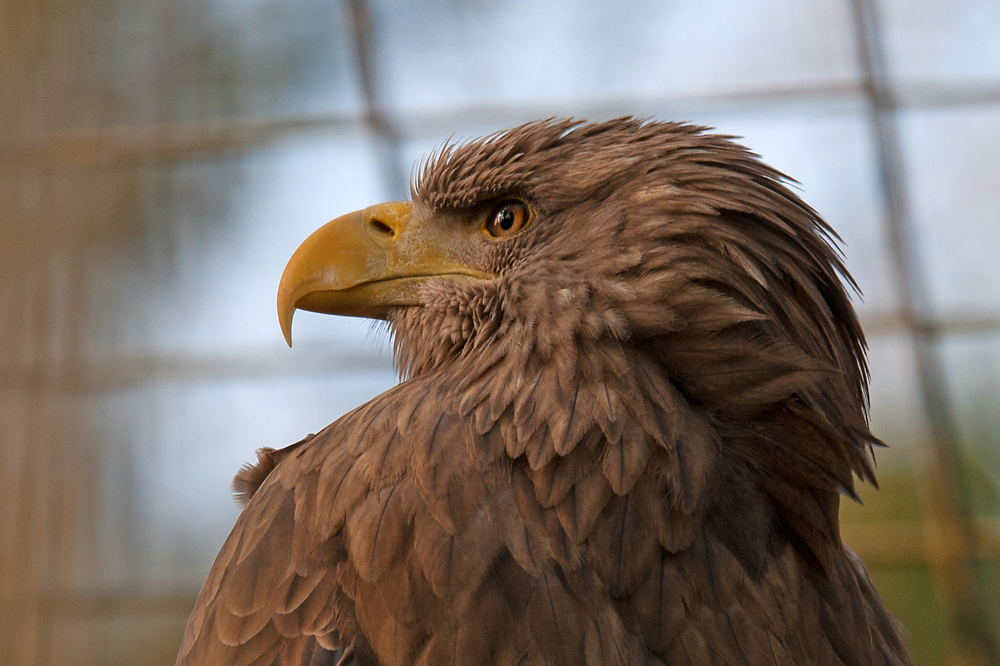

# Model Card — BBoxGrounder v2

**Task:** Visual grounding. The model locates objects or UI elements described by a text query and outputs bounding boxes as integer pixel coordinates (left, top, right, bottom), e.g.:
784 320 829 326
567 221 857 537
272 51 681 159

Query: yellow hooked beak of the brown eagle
278 201 492 346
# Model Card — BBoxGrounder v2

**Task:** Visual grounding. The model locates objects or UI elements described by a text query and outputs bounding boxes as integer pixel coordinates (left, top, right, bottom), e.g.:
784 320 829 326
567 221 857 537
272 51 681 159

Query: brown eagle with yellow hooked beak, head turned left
177 117 911 666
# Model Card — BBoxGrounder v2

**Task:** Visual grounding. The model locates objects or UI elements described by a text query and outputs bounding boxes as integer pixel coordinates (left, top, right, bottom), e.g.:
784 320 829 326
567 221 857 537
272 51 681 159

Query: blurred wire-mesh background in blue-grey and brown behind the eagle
0 0 1000 666
